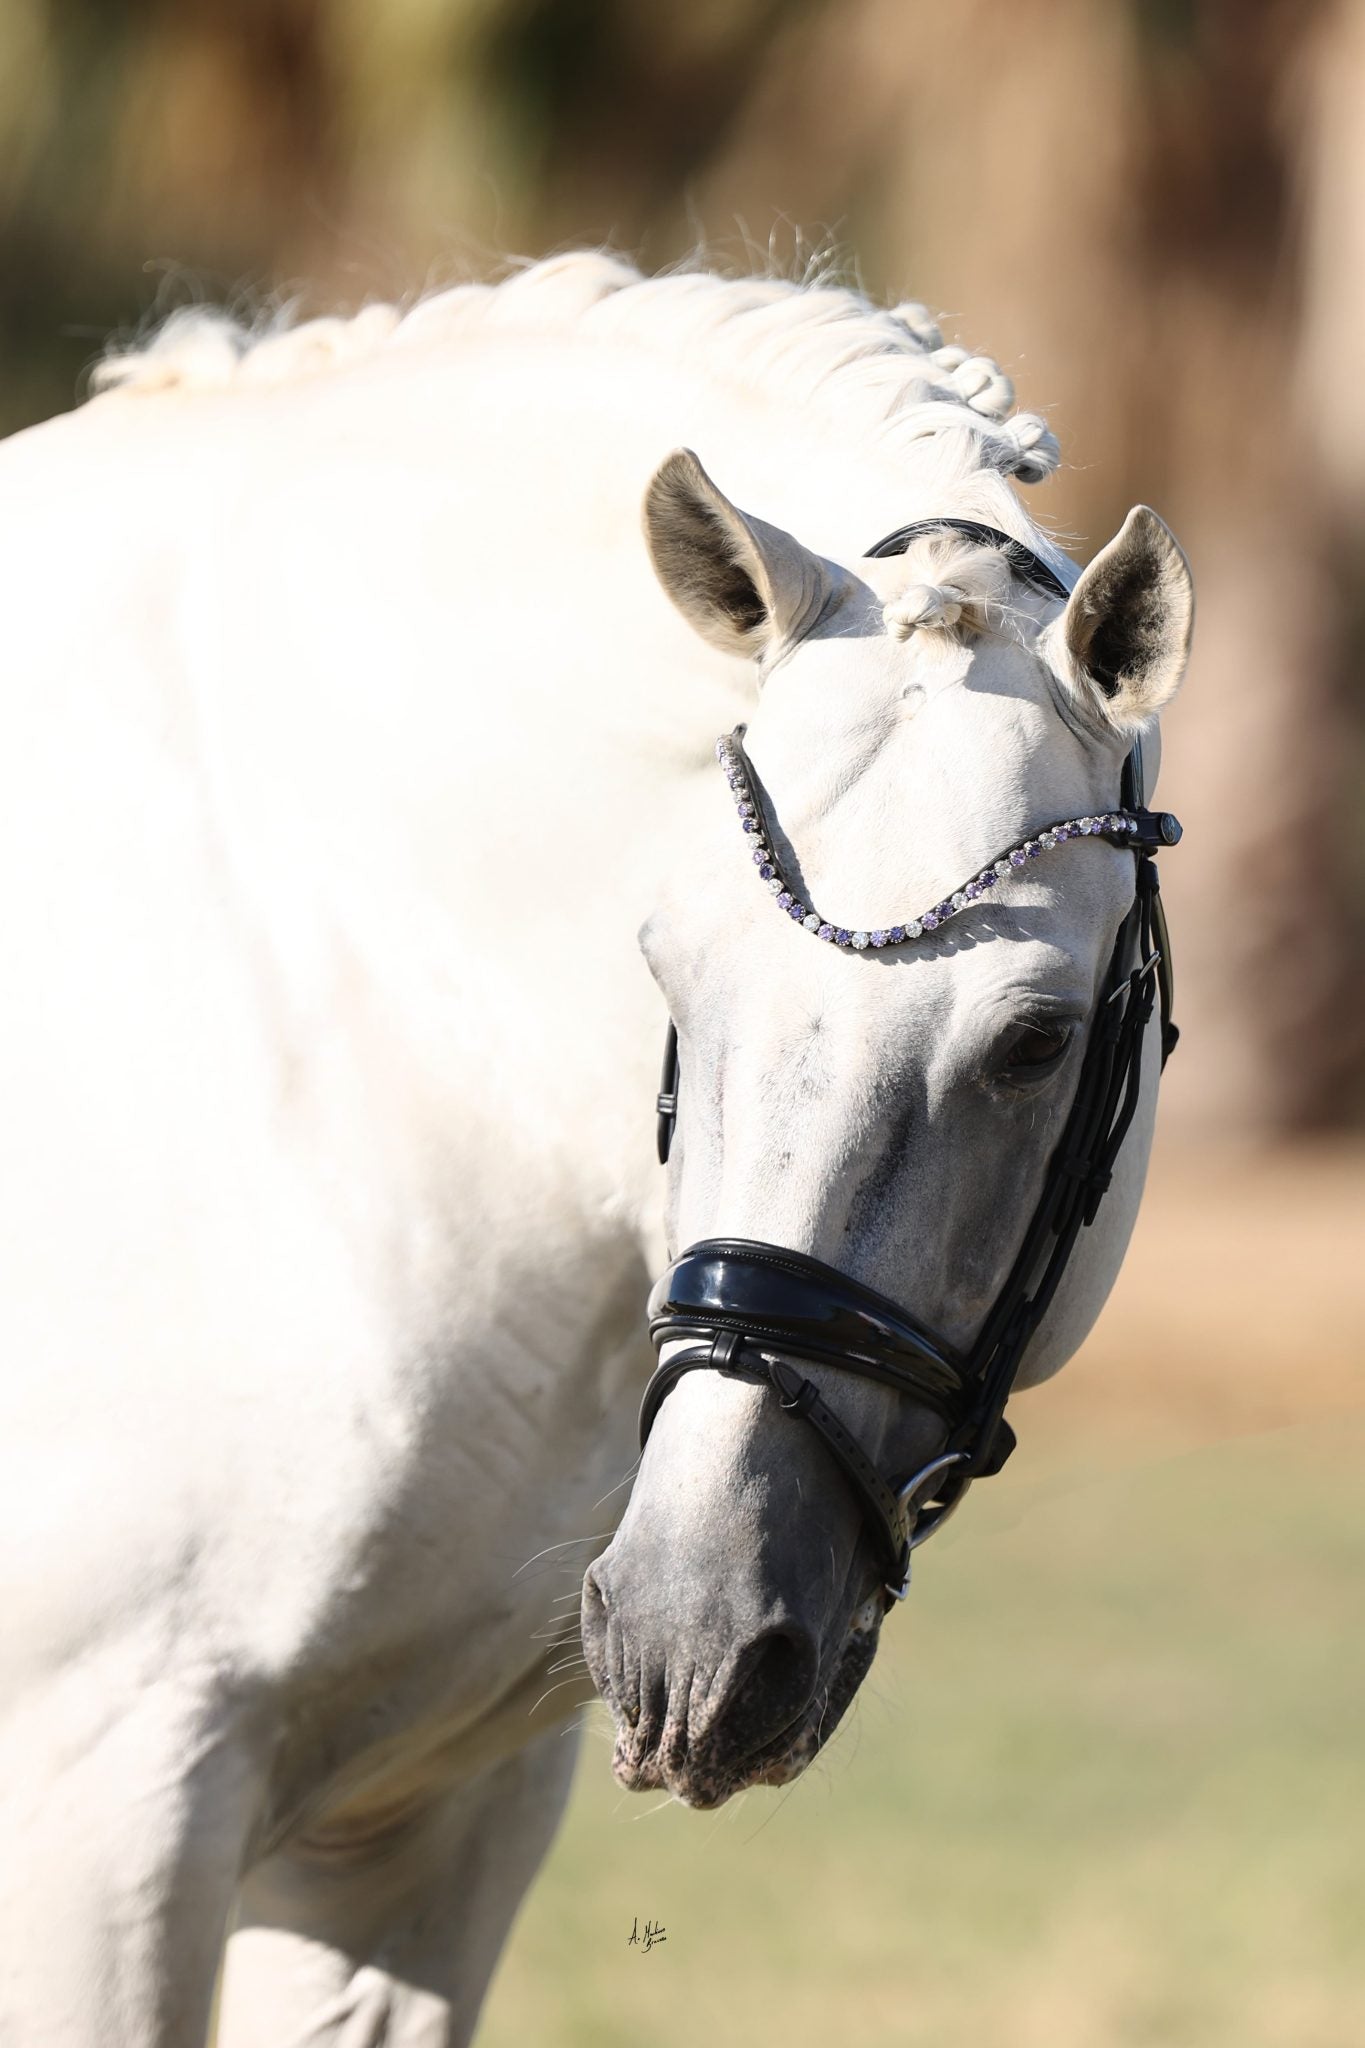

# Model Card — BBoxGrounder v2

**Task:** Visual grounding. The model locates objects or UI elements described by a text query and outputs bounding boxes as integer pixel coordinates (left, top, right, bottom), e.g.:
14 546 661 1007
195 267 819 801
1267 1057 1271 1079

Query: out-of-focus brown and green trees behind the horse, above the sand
0 0 1365 1135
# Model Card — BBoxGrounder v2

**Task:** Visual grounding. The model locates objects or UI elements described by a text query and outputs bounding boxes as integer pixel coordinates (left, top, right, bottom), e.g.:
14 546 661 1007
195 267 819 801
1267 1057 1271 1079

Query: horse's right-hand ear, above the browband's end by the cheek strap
1060 506 1195 733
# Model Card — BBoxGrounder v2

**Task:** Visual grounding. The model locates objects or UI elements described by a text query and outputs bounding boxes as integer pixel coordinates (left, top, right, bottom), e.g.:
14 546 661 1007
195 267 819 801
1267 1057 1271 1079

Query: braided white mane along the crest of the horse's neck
92 250 1058 483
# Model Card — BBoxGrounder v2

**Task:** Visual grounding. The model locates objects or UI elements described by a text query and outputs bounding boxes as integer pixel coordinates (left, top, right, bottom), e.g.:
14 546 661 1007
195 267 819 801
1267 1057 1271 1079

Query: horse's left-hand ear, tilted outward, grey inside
645 449 833 657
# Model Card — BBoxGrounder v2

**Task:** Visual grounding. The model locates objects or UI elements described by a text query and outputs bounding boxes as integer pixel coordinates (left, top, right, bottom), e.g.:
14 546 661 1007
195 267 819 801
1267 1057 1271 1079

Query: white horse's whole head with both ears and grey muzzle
583 457 1189 1806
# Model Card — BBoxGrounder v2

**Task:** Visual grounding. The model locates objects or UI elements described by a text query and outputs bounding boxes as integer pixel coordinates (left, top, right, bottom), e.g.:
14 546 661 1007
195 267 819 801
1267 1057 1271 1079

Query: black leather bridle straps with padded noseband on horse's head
641 518 1181 1604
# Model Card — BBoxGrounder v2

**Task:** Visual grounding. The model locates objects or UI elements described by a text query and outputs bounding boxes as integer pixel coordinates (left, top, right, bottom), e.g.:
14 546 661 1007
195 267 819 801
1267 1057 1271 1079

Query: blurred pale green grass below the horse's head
479 1417 1365 2048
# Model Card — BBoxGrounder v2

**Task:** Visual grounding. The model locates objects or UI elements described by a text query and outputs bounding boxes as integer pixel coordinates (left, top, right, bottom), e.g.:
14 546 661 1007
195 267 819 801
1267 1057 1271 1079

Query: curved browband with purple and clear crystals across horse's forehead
716 727 1181 952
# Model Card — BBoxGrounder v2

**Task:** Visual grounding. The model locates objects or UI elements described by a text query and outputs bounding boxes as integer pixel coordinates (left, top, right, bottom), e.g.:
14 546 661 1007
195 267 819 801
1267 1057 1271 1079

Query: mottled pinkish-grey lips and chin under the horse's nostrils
612 1595 882 1812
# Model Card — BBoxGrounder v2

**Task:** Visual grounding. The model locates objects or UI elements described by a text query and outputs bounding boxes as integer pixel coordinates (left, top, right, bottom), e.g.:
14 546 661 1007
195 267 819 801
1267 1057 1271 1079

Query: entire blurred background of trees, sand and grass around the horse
0 0 1365 2048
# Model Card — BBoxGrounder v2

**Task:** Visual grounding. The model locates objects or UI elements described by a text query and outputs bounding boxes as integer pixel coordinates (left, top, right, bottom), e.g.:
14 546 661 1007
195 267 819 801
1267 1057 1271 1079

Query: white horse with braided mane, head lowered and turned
0 256 1191 2048
